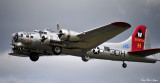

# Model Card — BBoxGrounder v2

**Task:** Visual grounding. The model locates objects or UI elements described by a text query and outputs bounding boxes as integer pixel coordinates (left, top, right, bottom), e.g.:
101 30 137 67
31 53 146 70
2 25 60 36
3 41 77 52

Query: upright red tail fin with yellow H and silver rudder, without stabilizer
131 25 151 51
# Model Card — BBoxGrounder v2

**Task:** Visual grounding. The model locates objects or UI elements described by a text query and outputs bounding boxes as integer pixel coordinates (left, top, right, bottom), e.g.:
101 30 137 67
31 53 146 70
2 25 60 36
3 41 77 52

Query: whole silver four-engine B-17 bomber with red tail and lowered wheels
9 22 160 68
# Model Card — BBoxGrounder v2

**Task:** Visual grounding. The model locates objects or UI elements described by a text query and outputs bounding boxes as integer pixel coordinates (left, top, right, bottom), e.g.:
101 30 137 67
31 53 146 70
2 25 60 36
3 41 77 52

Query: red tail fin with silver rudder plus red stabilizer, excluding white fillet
128 25 160 56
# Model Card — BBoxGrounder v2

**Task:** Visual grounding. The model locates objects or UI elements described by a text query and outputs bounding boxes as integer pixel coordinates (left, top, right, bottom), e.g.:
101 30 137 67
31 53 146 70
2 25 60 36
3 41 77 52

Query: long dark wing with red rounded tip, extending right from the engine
70 22 131 51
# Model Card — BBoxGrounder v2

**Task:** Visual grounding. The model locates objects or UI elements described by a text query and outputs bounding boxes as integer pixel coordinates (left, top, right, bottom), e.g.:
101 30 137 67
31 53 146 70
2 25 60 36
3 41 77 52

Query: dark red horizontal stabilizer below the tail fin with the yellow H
128 48 160 56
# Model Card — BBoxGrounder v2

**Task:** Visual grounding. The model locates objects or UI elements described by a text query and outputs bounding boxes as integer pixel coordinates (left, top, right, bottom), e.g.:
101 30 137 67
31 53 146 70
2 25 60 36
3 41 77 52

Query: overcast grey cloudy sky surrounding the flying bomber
0 0 160 83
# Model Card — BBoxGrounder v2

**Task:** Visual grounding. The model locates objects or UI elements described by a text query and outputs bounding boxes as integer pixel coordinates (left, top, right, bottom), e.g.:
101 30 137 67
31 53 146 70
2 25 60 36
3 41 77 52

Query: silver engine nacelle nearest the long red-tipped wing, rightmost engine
58 29 80 41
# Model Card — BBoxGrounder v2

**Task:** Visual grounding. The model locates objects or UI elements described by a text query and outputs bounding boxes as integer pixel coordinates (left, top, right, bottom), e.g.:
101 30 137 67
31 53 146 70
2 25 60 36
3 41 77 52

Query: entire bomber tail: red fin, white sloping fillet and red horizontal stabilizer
108 25 160 56
